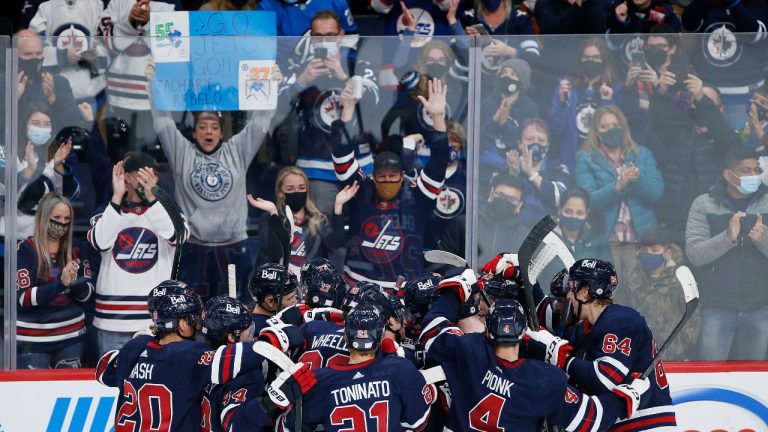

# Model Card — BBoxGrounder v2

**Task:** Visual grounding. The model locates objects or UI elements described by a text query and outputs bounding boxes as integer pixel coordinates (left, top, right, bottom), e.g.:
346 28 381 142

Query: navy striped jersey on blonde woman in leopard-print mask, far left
16 237 93 352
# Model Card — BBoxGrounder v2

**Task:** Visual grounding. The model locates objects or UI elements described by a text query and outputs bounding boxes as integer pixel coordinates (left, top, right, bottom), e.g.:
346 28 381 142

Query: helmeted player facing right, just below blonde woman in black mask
248 263 299 333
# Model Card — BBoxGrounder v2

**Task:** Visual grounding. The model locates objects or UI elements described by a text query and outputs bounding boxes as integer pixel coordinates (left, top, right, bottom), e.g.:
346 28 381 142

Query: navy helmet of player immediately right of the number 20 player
202 296 253 341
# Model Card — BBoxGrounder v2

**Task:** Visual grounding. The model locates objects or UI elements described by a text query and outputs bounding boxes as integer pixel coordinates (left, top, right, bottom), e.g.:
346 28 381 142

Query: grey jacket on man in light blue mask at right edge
685 179 768 309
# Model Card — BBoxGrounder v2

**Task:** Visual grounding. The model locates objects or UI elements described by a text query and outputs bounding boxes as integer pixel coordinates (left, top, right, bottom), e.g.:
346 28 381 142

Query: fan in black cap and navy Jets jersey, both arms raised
332 80 449 288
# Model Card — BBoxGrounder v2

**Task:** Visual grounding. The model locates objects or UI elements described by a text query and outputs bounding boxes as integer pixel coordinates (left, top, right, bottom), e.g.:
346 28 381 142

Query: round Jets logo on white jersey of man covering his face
112 227 157 273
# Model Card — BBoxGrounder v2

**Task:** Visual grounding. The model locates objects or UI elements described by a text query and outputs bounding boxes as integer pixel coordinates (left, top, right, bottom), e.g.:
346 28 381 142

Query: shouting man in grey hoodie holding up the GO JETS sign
147 66 282 298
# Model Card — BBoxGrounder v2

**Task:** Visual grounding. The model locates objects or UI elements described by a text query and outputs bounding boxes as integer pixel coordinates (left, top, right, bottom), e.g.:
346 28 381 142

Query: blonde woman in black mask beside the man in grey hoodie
248 166 348 274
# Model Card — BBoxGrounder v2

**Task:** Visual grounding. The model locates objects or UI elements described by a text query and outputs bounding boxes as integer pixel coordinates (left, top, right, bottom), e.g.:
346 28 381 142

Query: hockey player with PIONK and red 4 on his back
420 270 648 431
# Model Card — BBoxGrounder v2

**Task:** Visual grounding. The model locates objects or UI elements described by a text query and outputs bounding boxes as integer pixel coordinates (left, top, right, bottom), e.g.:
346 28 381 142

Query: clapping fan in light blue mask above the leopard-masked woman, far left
16 105 80 238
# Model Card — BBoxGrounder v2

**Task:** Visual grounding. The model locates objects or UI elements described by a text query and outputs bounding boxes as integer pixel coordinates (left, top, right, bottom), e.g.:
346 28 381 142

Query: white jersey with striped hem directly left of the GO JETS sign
101 0 175 111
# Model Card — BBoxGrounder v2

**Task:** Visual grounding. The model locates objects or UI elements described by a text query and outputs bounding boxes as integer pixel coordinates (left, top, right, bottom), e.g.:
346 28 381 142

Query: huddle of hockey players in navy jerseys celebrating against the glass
96 254 676 432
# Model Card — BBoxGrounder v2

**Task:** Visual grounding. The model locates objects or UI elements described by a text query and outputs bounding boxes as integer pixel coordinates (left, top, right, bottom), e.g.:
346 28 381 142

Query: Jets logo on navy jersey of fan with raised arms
360 216 403 264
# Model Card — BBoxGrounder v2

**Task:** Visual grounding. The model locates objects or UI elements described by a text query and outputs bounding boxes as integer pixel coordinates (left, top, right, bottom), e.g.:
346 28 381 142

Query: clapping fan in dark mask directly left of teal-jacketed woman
507 118 571 226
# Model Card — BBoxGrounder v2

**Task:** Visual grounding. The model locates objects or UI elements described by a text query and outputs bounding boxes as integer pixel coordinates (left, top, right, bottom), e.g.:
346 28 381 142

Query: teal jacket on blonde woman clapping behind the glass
574 146 664 239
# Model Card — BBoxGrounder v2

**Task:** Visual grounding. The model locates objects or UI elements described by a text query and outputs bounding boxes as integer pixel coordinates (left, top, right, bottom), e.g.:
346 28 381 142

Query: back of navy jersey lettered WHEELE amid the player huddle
298 321 349 370
